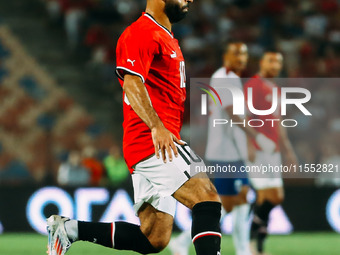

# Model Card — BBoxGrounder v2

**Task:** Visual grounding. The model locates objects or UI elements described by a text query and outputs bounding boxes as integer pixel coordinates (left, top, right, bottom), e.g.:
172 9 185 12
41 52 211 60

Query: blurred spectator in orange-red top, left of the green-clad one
82 146 104 186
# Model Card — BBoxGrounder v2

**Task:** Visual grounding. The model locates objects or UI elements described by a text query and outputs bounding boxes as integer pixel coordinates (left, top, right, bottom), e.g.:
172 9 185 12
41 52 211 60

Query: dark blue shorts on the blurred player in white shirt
209 160 249 196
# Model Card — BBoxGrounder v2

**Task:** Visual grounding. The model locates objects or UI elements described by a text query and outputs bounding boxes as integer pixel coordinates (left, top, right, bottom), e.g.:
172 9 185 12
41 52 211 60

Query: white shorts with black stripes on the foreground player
131 144 204 216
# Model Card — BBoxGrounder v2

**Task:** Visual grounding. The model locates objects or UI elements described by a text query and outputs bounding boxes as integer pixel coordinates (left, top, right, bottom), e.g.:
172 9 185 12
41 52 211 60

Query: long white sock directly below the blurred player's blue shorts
232 204 251 255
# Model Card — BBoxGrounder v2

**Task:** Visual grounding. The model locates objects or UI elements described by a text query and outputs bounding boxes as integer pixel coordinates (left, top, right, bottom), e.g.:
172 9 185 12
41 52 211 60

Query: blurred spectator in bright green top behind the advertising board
103 145 129 186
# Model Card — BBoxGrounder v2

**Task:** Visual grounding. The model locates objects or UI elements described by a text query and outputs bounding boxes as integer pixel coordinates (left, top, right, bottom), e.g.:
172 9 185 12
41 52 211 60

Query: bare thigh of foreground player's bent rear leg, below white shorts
138 203 174 246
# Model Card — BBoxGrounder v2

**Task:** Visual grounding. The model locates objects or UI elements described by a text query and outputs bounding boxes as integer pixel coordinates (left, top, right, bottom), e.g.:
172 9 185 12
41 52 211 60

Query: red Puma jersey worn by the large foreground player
116 13 186 173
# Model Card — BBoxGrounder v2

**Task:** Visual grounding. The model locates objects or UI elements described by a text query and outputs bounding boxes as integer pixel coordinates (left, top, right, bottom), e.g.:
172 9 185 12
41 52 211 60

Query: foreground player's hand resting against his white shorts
151 125 185 163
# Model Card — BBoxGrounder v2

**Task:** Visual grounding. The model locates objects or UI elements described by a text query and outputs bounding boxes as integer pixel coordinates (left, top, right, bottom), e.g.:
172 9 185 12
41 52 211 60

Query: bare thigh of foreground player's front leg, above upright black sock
173 173 220 209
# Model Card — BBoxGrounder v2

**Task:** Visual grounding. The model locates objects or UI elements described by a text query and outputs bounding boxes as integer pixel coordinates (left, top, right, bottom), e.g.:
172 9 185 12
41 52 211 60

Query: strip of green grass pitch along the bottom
0 233 340 255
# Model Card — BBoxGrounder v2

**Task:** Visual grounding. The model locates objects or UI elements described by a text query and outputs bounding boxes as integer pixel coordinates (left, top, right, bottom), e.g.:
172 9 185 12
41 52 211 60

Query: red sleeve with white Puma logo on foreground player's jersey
116 31 159 83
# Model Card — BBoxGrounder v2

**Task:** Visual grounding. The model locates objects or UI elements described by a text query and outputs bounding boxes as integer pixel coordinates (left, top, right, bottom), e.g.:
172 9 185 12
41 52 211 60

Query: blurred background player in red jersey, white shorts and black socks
244 51 297 254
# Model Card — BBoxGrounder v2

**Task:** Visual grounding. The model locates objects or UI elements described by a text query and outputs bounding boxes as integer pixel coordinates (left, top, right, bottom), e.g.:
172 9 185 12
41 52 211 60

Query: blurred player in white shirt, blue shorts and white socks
169 42 274 255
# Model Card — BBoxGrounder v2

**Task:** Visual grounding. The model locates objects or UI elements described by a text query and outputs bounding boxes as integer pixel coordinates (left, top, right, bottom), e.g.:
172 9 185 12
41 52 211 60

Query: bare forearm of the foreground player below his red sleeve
123 74 163 129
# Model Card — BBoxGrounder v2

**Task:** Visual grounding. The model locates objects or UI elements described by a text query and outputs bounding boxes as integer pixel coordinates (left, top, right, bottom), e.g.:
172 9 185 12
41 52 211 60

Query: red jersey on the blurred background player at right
244 74 281 151
